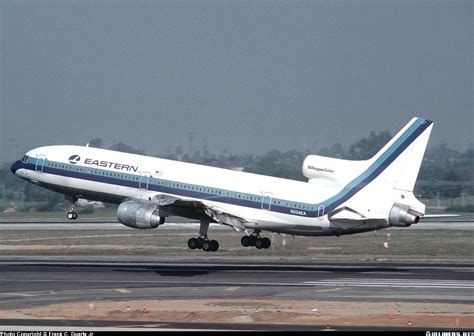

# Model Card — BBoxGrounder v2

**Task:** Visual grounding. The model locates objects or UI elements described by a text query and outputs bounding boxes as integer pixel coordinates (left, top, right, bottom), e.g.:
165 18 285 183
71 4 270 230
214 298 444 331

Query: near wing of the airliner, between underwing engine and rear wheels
151 194 249 231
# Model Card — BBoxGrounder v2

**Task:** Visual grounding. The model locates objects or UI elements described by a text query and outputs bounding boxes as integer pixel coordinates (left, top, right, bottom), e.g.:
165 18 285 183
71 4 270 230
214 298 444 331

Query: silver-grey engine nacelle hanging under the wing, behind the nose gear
117 201 160 229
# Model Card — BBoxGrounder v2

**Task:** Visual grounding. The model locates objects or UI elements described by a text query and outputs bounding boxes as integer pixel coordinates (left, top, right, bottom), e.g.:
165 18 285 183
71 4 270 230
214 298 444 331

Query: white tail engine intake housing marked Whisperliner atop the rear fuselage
302 155 368 185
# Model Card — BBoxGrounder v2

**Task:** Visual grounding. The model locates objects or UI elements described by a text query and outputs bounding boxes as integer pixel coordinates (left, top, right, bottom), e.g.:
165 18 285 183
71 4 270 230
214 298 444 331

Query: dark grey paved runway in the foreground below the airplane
0 258 474 330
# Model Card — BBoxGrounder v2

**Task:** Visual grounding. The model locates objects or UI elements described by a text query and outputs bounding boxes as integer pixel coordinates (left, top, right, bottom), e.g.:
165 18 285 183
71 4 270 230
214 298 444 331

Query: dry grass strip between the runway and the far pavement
0 224 474 258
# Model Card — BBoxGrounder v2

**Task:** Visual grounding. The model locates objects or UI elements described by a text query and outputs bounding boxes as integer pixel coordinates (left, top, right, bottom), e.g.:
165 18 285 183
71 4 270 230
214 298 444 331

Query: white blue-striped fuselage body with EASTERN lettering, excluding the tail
16 146 386 235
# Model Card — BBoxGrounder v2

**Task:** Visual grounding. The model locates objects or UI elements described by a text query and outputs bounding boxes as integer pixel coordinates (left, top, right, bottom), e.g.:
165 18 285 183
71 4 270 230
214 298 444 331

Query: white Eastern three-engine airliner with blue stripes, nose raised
11 118 433 252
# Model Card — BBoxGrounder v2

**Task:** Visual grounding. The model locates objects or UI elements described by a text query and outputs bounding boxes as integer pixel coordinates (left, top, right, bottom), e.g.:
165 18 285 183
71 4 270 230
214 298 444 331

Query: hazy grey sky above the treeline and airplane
0 0 474 159
